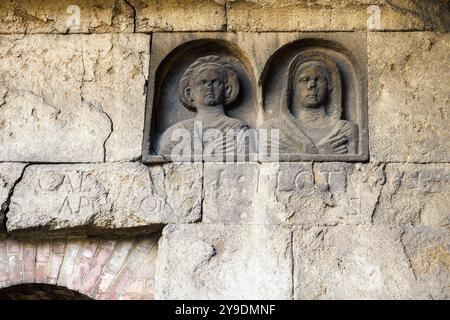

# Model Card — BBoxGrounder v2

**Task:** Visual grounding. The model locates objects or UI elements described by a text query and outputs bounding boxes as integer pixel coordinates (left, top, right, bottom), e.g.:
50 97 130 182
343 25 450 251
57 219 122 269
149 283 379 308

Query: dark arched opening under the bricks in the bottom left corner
0 283 91 300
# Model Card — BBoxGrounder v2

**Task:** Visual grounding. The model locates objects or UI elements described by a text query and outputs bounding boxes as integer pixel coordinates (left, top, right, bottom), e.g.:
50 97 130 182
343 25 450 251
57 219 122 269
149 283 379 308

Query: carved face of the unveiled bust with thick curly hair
187 68 228 107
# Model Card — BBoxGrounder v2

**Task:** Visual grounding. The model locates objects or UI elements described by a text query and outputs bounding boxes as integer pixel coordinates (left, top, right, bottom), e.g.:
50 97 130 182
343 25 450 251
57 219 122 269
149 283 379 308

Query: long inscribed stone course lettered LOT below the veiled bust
203 162 450 227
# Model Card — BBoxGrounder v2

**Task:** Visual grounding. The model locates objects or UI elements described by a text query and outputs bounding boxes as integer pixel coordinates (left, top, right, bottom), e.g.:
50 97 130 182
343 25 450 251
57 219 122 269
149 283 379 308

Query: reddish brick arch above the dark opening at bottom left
0 237 157 300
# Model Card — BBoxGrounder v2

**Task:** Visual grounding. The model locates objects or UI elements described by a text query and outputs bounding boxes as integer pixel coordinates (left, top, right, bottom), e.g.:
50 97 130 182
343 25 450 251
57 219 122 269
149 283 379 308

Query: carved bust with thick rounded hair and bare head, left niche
157 56 249 160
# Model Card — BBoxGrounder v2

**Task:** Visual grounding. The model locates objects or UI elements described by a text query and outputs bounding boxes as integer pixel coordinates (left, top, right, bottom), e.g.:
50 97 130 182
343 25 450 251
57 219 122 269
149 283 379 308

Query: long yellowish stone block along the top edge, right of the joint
227 0 450 31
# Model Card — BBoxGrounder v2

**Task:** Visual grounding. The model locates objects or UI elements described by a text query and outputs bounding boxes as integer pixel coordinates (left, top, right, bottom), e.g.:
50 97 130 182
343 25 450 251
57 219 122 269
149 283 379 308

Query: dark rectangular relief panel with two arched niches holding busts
143 32 369 163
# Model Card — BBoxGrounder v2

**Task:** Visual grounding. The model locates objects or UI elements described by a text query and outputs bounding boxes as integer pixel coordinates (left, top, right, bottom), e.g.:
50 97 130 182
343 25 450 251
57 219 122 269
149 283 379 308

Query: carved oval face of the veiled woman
292 64 328 108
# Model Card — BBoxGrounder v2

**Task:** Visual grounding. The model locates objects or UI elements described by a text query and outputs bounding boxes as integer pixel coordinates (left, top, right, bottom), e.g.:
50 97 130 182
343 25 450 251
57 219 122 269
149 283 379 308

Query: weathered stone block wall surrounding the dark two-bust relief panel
0 0 450 299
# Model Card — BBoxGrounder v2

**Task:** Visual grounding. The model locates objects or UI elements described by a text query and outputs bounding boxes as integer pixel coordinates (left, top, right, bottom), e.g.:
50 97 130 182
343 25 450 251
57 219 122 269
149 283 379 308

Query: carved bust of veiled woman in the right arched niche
263 50 358 154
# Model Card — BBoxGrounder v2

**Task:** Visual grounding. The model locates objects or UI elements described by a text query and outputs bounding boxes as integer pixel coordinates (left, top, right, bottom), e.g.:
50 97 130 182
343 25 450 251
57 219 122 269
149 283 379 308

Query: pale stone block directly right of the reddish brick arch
155 224 292 299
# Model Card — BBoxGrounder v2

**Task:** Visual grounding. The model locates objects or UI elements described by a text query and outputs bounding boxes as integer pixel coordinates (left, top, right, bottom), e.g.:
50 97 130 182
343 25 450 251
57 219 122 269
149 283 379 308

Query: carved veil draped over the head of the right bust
280 50 342 120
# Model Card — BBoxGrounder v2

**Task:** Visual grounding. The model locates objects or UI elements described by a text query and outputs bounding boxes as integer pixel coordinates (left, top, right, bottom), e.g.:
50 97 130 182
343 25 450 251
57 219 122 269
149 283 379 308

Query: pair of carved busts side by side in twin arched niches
156 50 358 160
